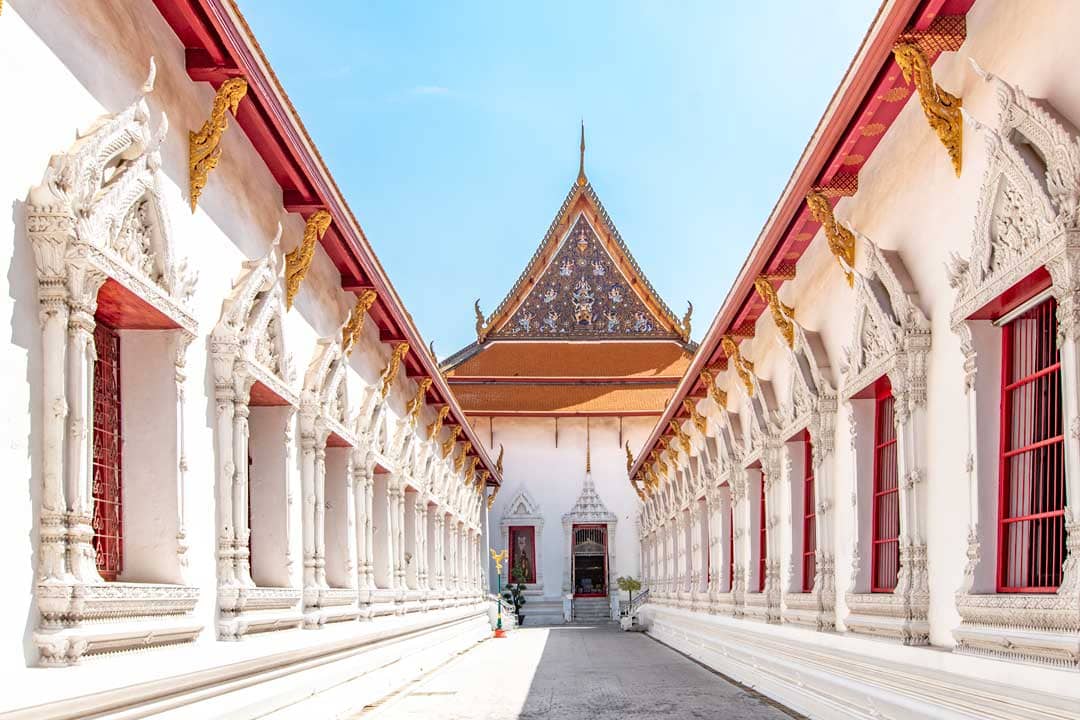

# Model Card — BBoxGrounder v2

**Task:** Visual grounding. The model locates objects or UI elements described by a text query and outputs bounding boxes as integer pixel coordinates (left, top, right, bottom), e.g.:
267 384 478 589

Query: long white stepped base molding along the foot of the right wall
639 603 1080 720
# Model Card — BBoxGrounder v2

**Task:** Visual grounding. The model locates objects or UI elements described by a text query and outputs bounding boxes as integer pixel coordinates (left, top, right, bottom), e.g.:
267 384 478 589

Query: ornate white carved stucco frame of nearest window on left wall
26 59 202 666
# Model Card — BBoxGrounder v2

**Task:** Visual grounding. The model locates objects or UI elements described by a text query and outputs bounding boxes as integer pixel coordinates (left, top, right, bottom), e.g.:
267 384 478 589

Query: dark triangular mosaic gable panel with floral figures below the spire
489 214 680 339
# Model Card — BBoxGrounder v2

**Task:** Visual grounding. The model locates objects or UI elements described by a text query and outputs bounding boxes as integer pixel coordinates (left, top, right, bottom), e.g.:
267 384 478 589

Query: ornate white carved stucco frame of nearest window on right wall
947 66 1080 669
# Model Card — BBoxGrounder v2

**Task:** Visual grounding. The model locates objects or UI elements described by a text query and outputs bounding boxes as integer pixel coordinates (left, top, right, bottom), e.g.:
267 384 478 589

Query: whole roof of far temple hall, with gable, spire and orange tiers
442 131 696 416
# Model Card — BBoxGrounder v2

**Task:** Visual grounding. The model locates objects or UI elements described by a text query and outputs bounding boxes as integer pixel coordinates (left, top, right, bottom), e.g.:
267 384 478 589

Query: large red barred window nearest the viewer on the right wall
997 298 1065 593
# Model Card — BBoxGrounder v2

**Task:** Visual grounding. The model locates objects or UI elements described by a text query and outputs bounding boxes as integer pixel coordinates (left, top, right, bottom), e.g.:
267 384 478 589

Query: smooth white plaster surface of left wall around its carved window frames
0 0 486 708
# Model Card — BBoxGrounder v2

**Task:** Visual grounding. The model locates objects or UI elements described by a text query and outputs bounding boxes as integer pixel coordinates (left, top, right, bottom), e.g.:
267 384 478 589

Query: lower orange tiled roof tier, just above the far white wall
454 382 675 416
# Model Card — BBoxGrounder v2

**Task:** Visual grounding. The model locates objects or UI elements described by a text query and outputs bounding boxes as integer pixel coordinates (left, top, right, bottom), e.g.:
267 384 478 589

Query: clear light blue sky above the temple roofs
241 0 878 357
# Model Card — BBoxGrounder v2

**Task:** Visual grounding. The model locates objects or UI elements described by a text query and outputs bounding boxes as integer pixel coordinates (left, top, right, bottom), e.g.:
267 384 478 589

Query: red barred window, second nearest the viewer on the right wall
870 378 900 593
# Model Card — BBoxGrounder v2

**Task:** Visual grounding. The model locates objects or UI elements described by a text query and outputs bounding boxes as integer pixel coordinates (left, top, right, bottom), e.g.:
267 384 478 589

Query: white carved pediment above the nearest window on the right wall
947 63 1080 323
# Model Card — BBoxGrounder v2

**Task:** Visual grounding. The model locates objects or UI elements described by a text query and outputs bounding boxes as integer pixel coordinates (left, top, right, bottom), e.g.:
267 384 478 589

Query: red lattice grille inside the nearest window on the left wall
91 320 124 582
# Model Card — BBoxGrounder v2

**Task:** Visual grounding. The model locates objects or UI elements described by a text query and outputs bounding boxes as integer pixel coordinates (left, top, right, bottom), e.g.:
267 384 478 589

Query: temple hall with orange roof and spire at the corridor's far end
443 132 694 622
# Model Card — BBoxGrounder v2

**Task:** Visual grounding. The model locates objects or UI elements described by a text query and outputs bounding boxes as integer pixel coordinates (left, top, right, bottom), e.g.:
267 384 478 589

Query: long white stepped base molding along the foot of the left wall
0 603 490 720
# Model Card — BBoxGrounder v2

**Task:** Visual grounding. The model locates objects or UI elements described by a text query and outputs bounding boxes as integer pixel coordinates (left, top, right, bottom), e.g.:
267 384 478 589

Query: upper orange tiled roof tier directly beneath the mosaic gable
446 341 693 379
